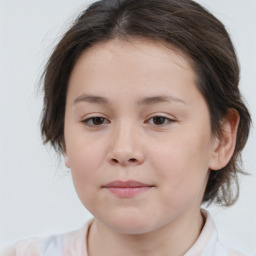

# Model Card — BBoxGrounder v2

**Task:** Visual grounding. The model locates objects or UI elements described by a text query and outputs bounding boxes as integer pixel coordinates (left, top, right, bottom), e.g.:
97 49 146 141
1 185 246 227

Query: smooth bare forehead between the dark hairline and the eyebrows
68 39 202 107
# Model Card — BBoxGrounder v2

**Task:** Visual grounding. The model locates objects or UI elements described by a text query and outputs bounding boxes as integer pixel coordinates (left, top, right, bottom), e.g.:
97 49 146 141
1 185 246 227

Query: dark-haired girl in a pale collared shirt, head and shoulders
1 0 250 256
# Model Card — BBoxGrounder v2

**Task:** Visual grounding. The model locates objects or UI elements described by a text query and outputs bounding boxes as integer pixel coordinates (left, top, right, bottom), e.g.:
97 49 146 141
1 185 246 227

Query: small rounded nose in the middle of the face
108 123 145 166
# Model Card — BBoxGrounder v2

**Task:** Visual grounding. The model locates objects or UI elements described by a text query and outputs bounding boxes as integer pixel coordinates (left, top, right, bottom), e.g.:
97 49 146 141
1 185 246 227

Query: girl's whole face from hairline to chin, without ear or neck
64 39 218 234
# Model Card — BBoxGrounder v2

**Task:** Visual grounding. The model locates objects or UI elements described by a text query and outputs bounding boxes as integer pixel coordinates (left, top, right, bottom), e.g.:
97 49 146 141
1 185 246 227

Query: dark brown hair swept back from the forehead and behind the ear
41 0 251 206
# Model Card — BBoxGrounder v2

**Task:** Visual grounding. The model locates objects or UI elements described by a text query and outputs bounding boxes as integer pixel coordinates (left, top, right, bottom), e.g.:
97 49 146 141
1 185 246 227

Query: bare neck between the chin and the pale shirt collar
88 210 203 256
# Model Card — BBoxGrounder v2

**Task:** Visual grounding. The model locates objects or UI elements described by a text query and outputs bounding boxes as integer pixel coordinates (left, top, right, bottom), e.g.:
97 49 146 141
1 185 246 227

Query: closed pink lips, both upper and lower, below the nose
103 180 154 198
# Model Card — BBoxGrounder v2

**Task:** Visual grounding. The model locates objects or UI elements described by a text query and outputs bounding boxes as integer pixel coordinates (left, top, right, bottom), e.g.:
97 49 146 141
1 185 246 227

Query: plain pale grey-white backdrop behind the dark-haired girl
0 0 256 252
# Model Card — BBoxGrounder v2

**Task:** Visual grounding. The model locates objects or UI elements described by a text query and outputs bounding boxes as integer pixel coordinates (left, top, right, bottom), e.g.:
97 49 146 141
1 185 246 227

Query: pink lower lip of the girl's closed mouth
106 187 152 198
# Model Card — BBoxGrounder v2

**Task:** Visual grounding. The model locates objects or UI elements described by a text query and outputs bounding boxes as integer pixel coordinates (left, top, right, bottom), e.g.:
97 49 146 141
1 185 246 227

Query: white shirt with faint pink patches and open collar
1 210 248 256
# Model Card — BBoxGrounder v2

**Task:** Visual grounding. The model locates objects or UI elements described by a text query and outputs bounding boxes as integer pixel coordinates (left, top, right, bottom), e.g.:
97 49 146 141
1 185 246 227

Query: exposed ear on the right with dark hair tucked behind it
209 109 240 170
